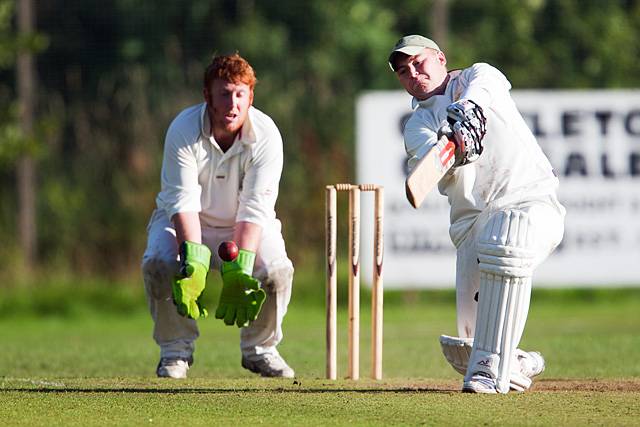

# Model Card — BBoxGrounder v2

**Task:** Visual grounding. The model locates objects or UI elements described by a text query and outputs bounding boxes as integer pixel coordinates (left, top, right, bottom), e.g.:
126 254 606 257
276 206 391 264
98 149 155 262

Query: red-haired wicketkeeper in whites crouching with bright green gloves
142 53 294 378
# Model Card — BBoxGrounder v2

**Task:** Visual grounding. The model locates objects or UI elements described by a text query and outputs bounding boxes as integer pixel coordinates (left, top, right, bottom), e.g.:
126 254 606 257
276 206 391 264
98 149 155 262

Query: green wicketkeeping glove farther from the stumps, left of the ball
172 241 211 319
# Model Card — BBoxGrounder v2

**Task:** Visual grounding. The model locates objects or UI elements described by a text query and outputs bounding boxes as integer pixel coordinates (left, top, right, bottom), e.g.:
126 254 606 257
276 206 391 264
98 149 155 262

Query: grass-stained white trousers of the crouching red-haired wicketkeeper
142 209 293 359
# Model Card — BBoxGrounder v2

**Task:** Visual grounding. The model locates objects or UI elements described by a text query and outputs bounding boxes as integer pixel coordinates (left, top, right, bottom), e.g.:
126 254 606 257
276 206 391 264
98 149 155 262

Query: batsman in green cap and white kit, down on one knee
388 35 565 393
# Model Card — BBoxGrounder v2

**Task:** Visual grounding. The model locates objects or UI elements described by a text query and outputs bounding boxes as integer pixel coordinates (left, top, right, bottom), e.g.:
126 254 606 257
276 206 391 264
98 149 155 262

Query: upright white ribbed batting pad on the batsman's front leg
467 210 535 393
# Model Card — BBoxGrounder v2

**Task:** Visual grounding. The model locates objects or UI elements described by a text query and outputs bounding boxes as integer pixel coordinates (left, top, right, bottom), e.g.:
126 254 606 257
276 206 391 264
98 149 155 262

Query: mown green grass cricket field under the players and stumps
0 282 640 425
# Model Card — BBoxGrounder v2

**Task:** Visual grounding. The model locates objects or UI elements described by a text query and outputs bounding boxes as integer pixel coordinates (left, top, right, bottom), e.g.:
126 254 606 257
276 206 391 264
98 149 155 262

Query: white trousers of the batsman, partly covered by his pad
452 196 565 338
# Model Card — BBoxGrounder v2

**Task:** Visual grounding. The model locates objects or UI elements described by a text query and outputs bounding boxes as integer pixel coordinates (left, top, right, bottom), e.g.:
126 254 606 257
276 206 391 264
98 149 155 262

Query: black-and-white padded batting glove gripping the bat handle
448 99 487 166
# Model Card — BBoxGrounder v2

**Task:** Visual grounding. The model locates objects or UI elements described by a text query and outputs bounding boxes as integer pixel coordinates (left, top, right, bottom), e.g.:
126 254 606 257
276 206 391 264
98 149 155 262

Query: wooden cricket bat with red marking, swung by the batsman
405 135 456 209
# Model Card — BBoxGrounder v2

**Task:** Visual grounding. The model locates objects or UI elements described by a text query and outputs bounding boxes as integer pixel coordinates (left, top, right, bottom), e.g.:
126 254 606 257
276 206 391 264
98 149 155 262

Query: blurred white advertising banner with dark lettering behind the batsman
356 90 640 289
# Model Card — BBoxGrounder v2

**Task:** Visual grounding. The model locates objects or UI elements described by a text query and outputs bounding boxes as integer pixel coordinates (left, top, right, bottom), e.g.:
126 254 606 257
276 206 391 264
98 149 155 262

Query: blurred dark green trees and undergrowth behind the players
0 0 640 285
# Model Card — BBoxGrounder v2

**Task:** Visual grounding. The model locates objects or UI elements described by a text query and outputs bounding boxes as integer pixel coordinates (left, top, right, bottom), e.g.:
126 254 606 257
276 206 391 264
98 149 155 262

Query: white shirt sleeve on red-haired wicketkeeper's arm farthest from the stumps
156 123 202 218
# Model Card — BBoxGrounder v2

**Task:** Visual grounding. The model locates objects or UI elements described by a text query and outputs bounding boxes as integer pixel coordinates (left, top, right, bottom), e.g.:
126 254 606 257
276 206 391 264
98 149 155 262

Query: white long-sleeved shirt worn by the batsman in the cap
404 63 558 246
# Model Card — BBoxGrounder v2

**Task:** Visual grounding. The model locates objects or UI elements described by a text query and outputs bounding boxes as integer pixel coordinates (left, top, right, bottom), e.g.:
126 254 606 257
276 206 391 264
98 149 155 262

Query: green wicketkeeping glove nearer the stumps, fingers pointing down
216 249 266 328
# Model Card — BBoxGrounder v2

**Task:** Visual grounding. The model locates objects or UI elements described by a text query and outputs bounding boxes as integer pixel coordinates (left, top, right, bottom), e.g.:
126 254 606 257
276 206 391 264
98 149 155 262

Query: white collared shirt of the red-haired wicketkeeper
156 103 283 231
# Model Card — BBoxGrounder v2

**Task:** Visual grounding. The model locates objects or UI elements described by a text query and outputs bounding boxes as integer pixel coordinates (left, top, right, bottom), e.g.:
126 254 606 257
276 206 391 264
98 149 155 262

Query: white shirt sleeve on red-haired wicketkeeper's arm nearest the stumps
236 125 283 227
